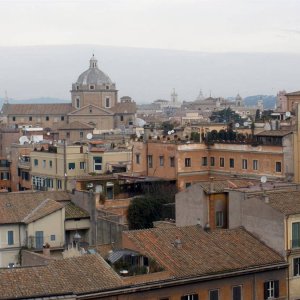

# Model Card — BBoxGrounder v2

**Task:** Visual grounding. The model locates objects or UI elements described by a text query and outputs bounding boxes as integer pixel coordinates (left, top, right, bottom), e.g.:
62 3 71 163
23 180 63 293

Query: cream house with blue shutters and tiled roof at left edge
0 192 65 267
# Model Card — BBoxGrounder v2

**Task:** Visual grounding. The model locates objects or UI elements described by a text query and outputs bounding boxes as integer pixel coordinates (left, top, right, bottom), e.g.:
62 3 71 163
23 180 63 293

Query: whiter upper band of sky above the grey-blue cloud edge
0 0 300 53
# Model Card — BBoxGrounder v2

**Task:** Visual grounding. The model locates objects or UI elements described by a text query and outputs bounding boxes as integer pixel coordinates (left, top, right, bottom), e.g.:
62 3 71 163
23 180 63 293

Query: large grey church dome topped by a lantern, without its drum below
76 54 112 85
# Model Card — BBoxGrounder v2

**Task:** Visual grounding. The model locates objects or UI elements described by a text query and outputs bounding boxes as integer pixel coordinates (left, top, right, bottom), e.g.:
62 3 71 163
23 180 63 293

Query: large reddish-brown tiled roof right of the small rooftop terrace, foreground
124 226 284 277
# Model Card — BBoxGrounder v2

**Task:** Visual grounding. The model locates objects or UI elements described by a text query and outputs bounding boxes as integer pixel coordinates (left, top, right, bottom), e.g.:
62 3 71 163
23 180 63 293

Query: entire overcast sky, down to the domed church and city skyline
0 0 300 102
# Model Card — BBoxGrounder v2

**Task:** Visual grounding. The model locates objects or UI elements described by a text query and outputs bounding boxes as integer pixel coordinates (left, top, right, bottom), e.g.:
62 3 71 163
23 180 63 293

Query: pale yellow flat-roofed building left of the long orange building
30 142 131 190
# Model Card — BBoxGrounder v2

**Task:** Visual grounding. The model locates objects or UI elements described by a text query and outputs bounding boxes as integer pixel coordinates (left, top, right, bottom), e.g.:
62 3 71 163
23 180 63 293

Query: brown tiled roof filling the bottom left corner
0 254 122 299
